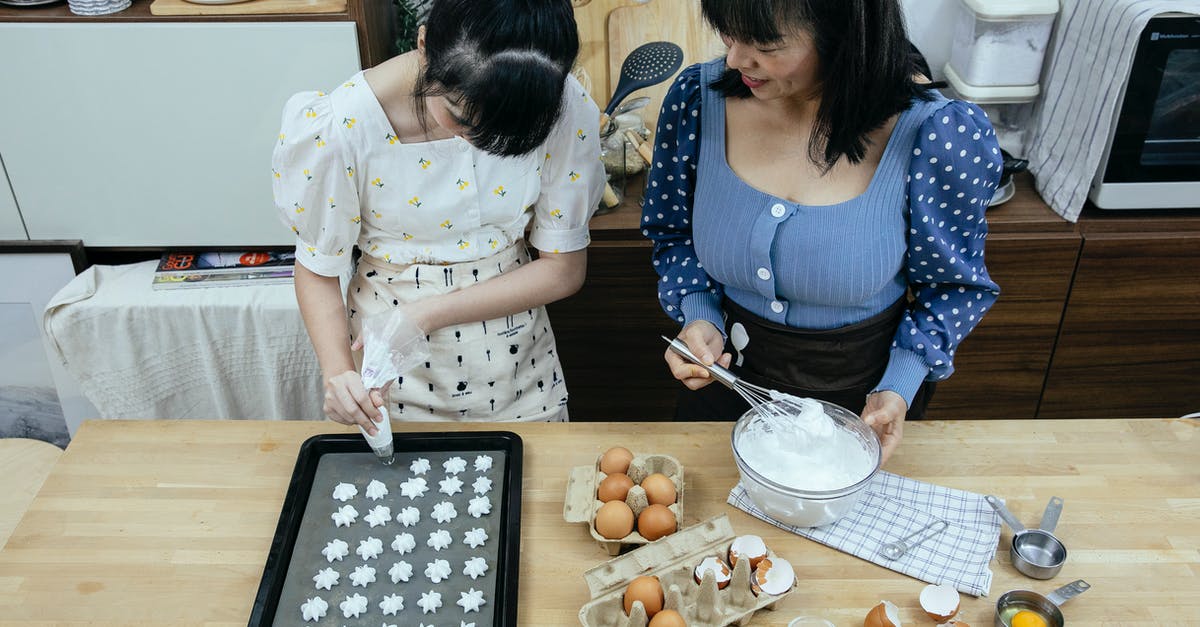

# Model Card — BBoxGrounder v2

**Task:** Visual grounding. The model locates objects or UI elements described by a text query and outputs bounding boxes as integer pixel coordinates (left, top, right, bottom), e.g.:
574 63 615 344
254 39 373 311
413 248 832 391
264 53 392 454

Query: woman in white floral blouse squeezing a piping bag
272 0 605 432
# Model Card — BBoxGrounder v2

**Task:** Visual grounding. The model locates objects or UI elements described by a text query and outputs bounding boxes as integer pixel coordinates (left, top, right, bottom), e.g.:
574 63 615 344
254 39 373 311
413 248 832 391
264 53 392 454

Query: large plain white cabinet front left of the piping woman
0 22 359 246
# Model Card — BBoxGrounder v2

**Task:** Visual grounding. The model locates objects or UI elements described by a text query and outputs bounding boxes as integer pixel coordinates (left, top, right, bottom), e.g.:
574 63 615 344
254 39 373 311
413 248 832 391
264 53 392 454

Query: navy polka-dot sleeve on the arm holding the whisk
642 65 725 329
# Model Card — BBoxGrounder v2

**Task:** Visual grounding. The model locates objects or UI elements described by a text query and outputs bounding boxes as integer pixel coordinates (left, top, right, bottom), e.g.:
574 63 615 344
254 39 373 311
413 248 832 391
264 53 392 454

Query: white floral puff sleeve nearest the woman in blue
529 76 605 252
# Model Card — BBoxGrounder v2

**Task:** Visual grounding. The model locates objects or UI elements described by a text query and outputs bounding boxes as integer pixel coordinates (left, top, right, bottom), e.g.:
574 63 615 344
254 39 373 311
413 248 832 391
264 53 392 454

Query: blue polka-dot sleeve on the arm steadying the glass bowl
877 101 1002 405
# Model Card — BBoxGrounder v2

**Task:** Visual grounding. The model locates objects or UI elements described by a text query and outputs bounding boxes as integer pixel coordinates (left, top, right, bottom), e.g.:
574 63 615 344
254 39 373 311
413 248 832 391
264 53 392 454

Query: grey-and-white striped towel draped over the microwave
1016 0 1200 222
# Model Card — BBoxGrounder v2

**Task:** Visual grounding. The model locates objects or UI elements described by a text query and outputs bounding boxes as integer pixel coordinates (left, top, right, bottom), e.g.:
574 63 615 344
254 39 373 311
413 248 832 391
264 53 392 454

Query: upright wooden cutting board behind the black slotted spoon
609 0 725 131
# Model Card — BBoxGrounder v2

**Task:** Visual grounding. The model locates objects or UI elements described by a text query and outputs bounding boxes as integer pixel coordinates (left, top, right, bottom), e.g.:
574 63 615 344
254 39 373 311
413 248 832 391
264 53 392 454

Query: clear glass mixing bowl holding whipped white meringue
731 399 882 527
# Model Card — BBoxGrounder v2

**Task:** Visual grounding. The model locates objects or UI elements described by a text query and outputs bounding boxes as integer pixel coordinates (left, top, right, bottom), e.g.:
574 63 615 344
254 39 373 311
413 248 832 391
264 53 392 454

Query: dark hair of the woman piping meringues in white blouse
414 0 580 155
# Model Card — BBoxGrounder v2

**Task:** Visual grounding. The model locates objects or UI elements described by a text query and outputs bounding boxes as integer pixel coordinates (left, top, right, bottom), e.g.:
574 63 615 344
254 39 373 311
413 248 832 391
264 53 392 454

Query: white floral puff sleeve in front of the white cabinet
271 91 362 276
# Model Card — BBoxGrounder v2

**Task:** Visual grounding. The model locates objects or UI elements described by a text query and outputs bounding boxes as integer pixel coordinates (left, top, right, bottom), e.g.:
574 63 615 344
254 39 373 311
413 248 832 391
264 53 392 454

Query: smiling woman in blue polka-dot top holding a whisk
642 0 1001 459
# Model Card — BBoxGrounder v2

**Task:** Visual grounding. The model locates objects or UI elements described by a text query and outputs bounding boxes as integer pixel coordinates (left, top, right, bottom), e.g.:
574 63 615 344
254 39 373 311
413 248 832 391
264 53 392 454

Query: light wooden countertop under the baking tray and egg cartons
0 419 1200 627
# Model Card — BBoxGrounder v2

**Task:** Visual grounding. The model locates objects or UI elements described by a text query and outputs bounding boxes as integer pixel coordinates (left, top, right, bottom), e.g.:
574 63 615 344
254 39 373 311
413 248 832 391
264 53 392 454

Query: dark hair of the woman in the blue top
701 0 932 171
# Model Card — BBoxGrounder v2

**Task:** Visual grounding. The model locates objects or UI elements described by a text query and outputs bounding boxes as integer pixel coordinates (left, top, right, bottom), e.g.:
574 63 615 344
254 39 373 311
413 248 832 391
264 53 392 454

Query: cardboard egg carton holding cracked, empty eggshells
580 514 797 627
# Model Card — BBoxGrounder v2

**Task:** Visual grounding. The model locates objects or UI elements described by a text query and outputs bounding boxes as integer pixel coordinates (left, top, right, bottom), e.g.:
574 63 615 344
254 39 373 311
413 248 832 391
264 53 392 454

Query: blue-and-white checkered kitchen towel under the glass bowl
728 471 1000 597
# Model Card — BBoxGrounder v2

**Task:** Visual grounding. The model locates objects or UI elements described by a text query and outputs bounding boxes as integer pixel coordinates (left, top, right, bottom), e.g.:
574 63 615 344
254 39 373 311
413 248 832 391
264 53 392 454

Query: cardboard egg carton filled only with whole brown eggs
563 454 684 555
